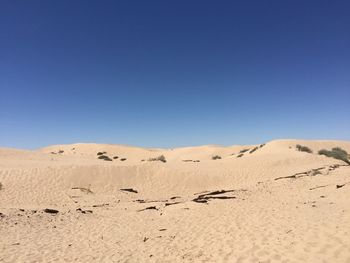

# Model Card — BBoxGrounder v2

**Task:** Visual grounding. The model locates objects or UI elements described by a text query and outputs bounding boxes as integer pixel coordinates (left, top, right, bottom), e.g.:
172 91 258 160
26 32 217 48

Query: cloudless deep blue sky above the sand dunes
0 0 350 149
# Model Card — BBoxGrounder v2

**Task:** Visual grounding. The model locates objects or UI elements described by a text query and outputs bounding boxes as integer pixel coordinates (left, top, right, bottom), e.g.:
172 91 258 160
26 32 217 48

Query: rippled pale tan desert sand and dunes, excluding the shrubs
0 140 350 262
